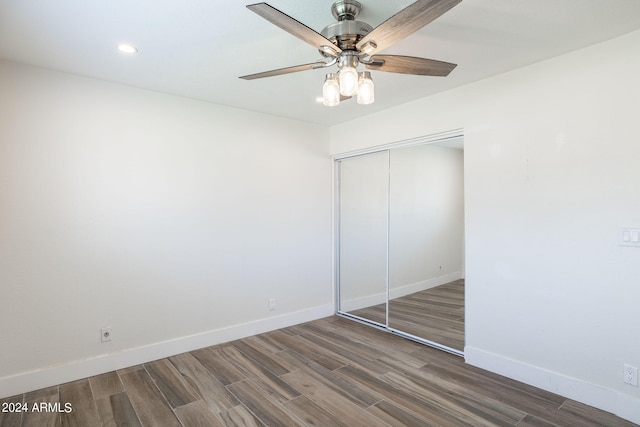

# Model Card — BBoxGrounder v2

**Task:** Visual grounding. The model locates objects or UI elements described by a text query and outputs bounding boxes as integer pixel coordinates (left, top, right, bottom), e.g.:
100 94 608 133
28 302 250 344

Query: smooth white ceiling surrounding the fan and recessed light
0 0 640 125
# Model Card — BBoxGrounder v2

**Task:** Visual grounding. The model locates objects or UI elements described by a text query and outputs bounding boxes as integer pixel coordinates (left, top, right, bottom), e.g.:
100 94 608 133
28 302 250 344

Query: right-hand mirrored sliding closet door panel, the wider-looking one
388 138 464 351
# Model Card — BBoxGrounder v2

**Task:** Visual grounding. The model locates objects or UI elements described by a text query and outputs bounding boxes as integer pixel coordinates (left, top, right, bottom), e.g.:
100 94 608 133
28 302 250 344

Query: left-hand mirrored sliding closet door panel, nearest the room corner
337 151 389 325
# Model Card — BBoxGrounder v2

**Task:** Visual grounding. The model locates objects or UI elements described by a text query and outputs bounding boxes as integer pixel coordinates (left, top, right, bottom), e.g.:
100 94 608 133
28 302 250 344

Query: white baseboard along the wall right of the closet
464 346 640 424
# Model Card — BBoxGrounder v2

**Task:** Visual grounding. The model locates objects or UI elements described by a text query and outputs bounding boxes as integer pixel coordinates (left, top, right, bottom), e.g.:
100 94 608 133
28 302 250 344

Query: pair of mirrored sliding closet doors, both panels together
336 136 464 355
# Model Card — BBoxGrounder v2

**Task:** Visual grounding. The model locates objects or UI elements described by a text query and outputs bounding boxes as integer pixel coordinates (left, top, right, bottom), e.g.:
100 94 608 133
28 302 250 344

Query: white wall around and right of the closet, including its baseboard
331 32 640 422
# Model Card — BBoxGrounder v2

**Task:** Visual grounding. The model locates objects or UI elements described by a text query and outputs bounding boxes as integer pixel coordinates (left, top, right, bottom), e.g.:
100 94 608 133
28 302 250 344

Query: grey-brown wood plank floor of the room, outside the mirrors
0 316 635 427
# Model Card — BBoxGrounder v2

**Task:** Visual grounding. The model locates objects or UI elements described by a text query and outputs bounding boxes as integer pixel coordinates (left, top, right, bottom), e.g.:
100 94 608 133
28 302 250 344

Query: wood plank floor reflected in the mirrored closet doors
351 279 464 351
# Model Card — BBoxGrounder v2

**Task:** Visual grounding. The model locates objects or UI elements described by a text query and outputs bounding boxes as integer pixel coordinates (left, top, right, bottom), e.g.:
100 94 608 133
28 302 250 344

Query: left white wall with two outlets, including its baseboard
0 62 333 397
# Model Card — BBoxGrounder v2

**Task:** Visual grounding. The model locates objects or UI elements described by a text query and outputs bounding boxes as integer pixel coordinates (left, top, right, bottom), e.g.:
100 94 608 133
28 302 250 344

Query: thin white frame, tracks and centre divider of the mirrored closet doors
332 129 464 357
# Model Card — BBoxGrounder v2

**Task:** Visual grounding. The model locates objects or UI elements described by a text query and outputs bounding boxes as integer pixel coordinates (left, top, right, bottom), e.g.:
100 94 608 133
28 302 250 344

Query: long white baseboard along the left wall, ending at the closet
0 304 335 399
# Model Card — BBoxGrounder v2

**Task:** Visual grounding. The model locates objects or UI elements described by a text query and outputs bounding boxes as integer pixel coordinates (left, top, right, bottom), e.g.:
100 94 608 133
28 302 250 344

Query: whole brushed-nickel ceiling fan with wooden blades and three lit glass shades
240 0 462 106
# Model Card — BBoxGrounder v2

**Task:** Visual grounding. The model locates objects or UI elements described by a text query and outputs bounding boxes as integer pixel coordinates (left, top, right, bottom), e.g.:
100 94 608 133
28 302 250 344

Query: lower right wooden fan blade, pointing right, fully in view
365 55 457 77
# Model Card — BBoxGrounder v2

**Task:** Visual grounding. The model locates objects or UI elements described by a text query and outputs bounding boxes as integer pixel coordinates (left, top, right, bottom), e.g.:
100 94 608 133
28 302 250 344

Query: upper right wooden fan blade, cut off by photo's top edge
356 0 462 55
